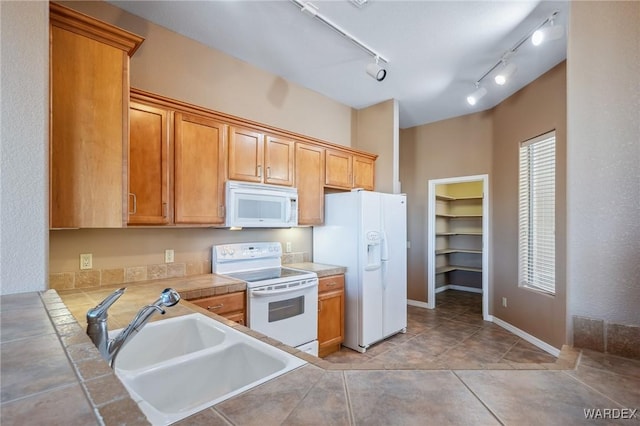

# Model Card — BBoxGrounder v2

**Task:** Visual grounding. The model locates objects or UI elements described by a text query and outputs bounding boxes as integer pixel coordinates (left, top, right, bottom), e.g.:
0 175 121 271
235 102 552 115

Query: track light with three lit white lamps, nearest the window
467 10 564 106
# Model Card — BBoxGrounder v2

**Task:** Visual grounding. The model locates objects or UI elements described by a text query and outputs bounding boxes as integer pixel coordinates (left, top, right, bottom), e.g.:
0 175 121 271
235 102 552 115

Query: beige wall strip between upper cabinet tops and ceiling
62 1 352 146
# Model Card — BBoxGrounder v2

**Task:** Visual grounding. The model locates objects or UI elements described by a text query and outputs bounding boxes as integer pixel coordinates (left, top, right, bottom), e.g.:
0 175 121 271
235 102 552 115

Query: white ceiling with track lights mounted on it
110 0 569 128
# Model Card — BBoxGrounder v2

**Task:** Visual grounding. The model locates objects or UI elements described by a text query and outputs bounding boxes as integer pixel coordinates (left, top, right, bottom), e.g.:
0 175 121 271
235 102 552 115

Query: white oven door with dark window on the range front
247 279 318 347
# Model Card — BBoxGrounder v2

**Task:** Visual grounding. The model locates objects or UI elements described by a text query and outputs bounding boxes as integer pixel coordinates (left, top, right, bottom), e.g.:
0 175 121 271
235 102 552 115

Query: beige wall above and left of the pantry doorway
400 112 493 302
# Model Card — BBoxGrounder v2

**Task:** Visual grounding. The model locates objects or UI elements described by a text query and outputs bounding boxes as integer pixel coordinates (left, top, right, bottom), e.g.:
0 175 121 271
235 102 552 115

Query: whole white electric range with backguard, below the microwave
211 242 318 356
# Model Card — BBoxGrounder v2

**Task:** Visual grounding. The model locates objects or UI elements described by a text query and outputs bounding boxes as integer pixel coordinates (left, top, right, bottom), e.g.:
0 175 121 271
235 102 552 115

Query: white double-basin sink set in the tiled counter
114 313 306 425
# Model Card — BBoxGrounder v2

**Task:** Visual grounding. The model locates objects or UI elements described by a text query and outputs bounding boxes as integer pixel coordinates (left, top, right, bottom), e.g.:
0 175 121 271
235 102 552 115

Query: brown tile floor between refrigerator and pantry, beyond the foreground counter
325 290 556 369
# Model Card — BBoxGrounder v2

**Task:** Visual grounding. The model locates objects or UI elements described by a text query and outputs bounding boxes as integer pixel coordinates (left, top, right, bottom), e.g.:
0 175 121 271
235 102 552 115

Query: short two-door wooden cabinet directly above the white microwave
229 126 294 186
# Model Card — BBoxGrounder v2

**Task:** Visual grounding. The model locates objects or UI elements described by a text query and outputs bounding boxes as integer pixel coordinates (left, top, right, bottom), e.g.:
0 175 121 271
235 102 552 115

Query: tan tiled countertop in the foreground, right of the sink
201 351 640 426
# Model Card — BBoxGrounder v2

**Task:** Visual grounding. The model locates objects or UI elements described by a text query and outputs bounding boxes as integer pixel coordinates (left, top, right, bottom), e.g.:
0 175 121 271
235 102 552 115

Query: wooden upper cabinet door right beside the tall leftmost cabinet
129 102 170 225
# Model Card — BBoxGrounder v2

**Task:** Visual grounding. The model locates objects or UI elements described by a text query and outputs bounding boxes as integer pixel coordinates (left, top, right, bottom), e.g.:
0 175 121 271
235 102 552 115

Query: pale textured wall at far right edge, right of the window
567 2 640 333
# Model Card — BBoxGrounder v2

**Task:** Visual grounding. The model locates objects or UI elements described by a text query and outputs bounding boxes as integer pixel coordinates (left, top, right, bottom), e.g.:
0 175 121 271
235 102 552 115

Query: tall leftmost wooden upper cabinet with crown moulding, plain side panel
49 3 143 228
